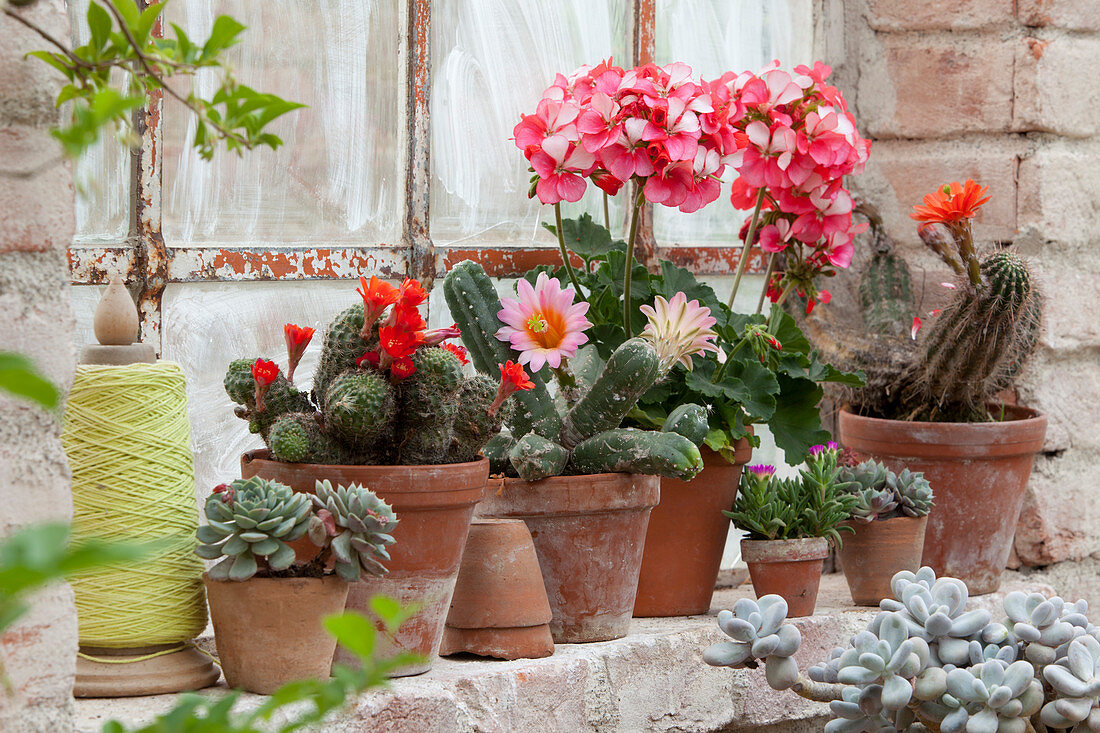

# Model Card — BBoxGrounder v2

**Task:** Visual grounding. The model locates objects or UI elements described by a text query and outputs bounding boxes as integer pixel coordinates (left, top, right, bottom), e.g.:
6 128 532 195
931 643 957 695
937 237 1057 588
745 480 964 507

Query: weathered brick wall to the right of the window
817 0 1100 566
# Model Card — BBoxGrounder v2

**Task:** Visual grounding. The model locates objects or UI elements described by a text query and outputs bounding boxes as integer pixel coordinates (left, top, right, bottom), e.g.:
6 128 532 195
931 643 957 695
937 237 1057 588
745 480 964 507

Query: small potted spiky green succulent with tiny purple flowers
726 444 856 616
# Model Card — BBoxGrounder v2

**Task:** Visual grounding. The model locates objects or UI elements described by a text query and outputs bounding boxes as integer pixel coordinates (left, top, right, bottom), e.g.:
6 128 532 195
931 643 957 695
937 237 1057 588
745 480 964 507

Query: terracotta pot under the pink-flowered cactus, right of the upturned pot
477 473 660 644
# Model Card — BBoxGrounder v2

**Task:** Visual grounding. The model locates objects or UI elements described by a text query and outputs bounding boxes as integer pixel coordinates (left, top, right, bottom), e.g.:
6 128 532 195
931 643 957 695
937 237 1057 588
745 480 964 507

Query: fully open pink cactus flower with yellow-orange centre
496 272 592 373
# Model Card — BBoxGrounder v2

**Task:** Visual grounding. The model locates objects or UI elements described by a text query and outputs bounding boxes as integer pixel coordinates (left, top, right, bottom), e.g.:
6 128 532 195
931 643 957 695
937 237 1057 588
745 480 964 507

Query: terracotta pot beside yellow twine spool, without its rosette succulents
202 573 348 694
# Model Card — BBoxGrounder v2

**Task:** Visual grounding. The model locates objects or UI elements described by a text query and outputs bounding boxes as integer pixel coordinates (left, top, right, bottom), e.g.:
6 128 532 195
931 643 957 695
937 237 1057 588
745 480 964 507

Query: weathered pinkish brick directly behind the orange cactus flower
851 140 1016 243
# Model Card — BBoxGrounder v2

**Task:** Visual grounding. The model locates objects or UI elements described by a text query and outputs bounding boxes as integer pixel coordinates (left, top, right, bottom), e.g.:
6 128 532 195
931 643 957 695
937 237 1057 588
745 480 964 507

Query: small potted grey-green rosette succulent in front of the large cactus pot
837 461 932 605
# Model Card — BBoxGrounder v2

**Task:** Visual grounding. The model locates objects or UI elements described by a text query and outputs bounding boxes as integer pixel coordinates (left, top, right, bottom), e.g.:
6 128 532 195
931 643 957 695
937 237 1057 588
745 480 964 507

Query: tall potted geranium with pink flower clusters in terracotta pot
495 63 869 615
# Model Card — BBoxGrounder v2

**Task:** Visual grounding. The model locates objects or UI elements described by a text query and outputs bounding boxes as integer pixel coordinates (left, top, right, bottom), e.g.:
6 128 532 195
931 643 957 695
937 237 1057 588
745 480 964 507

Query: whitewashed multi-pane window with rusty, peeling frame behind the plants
69 0 813 488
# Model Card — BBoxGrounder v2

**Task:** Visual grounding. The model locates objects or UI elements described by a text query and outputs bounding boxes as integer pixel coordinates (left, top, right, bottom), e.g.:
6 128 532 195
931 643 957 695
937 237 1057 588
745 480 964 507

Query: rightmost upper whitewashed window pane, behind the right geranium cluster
653 0 813 244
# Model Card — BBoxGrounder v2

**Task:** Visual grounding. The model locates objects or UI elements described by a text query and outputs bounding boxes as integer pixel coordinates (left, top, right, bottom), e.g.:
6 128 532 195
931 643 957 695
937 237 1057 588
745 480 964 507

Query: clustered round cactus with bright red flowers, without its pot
224 277 525 464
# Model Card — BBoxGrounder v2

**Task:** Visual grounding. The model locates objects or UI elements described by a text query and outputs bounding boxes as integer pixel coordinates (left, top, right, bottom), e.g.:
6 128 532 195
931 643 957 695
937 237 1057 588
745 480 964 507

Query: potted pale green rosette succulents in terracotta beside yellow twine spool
195 477 397 694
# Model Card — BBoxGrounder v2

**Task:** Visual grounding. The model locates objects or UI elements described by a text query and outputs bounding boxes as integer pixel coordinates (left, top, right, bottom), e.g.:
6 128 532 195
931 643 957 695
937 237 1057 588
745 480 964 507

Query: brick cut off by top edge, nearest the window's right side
866 0 1015 31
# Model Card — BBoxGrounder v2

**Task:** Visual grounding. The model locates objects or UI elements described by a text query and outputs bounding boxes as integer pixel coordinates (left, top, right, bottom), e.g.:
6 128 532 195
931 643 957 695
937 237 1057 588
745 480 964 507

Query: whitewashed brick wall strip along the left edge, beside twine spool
0 0 77 733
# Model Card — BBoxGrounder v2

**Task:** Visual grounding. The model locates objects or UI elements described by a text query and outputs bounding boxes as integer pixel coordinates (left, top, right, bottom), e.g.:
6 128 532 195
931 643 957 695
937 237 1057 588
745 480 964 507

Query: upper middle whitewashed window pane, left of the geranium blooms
431 0 630 244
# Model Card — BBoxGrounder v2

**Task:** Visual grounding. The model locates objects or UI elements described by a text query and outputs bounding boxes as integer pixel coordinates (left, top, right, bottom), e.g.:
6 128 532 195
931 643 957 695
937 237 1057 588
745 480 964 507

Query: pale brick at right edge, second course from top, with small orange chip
1012 35 1100 138
